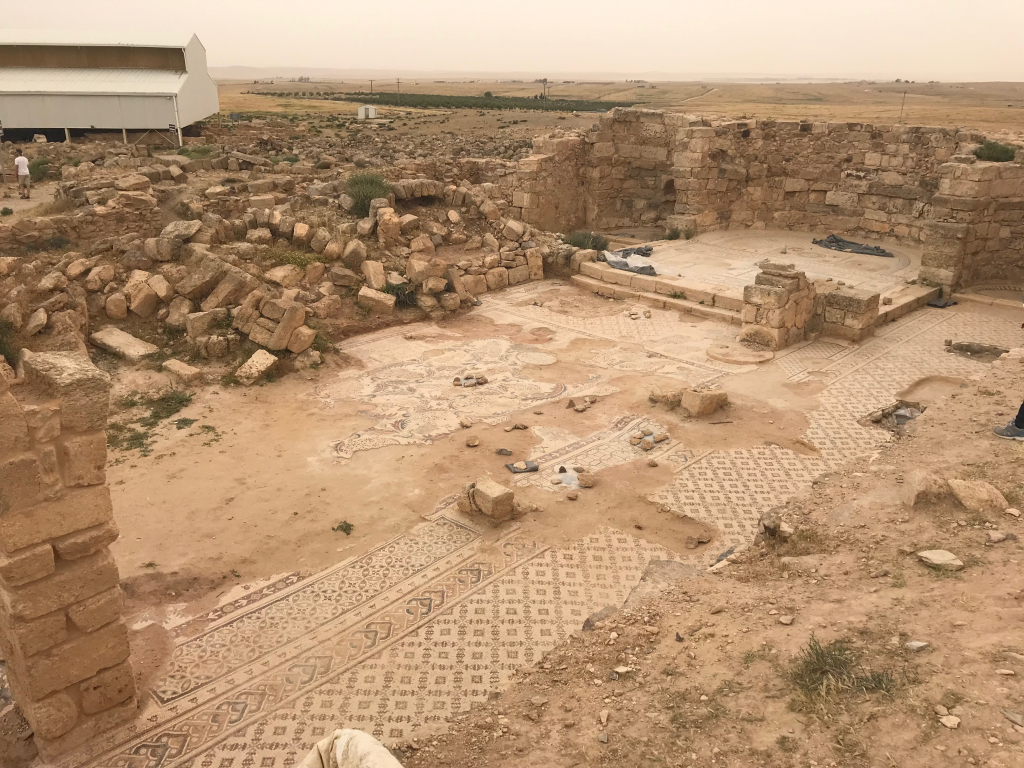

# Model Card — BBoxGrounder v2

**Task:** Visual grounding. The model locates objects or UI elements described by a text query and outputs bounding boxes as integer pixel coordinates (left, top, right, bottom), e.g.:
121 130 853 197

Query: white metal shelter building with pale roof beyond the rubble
0 30 220 144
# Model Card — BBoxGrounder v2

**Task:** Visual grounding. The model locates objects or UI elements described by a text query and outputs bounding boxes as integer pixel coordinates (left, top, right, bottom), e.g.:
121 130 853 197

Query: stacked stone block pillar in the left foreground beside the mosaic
0 352 136 758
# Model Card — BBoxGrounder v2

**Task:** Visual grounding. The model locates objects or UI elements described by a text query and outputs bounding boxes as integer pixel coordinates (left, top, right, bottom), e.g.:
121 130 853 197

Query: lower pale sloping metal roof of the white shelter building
0 67 187 96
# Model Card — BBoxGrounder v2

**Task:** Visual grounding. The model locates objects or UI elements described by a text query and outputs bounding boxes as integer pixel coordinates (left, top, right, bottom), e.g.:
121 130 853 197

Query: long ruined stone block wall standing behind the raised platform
500 109 1024 291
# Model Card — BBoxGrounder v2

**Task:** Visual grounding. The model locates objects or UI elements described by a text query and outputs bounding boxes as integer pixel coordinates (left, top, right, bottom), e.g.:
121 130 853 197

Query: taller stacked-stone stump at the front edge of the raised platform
739 261 817 349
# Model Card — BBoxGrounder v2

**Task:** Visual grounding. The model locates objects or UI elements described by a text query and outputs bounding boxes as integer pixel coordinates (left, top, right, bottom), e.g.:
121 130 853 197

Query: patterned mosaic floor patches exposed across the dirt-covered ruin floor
62 283 1019 768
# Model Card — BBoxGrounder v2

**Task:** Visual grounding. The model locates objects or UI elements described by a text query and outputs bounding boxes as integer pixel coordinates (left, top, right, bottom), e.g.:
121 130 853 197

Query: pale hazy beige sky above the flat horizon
18 0 1024 81
